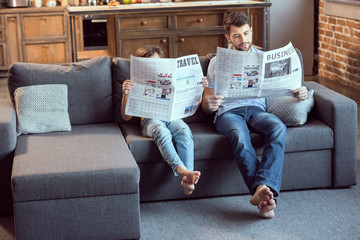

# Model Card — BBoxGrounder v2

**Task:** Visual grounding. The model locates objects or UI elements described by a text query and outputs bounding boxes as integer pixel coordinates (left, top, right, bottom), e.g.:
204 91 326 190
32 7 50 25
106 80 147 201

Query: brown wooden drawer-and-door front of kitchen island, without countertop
108 7 264 58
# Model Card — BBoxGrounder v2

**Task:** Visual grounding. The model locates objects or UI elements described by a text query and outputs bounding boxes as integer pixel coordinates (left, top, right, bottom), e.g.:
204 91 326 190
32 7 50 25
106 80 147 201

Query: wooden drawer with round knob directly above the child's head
118 16 168 30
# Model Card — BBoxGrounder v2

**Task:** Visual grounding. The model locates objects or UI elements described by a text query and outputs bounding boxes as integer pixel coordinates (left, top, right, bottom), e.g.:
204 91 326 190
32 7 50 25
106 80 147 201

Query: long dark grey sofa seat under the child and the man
120 116 334 163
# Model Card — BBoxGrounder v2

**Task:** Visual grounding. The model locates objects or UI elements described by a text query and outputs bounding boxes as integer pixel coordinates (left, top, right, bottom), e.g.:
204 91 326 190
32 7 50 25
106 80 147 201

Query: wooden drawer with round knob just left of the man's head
176 13 223 28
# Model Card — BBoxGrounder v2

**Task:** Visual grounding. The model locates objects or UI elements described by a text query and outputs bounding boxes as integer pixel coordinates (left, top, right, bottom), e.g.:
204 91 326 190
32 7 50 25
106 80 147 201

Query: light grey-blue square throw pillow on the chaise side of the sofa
14 84 71 135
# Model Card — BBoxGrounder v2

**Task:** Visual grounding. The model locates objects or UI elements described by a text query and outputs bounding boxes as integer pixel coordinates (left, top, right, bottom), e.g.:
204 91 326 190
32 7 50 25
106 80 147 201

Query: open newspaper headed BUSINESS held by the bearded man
214 42 302 99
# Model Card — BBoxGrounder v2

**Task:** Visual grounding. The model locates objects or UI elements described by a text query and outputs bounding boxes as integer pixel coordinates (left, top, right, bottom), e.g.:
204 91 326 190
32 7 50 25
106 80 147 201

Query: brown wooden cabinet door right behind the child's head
118 37 169 58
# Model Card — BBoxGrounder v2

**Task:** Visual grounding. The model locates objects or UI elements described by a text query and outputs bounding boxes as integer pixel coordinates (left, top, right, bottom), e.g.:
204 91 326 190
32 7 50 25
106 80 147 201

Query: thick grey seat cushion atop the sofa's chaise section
12 123 140 202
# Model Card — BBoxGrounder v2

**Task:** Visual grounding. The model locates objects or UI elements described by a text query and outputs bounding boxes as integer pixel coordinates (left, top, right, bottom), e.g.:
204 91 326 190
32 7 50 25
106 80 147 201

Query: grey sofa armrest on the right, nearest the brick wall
304 82 357 187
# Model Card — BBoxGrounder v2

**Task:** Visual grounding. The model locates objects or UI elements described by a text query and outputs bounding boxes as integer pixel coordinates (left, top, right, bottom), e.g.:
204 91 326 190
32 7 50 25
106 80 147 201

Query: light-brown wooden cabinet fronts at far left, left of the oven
0 7 71 70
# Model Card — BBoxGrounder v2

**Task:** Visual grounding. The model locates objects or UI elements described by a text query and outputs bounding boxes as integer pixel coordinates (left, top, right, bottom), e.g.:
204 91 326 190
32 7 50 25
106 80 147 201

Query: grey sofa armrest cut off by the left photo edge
0 99 17 162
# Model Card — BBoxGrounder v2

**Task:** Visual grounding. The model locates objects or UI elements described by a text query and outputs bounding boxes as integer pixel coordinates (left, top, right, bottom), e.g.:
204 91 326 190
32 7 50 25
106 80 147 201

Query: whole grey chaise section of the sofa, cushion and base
12 123 140 240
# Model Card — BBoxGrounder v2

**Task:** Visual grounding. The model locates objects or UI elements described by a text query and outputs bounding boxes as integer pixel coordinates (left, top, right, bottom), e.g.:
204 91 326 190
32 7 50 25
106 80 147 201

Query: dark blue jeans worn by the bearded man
215 106 286 197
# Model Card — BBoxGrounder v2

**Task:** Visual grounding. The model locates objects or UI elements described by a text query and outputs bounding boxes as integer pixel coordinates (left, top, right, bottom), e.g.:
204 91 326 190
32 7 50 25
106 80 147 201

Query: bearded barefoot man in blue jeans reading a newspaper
202 12 308 218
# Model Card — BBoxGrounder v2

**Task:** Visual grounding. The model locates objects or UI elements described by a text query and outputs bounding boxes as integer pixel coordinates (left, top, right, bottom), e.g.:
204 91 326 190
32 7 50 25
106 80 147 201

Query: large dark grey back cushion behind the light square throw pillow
8 57 113 125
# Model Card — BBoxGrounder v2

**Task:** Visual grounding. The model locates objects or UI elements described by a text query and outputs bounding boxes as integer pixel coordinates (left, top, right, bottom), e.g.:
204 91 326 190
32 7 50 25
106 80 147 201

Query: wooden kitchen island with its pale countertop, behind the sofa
65 1 271 61
